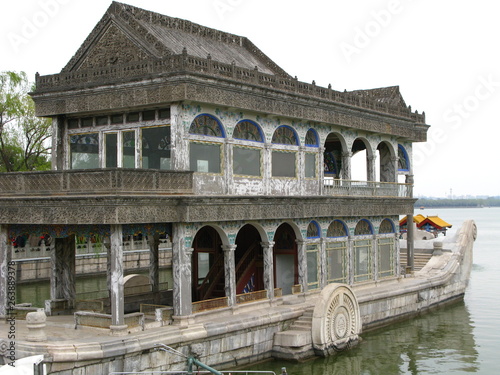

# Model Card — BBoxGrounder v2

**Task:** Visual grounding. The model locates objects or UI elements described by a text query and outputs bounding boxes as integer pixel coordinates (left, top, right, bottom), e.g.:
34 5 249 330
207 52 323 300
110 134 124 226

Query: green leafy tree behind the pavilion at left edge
0 72 51 172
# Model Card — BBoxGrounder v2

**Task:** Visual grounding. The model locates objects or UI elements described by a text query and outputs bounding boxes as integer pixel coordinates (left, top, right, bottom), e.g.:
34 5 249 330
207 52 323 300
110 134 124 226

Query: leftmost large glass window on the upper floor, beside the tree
70 133 99 169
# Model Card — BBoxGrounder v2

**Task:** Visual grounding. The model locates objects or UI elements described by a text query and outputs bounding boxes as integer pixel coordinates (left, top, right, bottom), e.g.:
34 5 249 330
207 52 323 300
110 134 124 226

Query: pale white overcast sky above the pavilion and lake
0 0 500 197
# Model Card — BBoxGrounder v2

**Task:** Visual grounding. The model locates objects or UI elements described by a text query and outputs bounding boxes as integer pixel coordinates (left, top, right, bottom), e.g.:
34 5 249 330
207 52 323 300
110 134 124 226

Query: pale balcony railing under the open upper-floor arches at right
323 178 413 198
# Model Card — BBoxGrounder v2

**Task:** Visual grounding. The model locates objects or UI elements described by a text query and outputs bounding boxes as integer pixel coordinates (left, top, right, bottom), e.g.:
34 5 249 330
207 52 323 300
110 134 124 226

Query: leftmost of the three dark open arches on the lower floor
192 226 225 302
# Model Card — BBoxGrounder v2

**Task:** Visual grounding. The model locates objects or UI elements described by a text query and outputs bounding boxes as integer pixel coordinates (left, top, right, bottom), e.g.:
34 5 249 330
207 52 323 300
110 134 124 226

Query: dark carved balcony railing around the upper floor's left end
0 168 193 196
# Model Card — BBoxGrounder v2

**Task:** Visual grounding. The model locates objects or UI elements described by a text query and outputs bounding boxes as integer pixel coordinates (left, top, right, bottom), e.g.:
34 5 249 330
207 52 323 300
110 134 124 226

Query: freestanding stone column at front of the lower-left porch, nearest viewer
109 224 127 334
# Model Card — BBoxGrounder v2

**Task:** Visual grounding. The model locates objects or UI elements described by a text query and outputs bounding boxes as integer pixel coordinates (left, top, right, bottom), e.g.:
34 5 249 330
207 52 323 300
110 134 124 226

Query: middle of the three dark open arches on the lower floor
235 224 264 294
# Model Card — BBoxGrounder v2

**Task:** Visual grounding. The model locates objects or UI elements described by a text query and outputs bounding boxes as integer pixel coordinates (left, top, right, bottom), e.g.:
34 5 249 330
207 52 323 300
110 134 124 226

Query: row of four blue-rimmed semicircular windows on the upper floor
189 114 319 147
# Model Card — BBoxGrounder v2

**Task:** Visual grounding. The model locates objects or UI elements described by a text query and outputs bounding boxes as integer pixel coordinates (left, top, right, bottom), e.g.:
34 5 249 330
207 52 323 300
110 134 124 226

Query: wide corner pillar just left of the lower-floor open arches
172 223 193 316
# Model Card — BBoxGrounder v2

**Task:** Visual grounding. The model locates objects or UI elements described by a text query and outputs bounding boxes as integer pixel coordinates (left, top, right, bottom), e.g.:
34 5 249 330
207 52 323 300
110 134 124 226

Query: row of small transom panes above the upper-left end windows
67 108 170 129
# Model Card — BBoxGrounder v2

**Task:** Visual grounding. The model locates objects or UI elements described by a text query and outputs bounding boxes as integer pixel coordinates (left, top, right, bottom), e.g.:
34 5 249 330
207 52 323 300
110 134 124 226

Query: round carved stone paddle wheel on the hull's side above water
312 284 362 356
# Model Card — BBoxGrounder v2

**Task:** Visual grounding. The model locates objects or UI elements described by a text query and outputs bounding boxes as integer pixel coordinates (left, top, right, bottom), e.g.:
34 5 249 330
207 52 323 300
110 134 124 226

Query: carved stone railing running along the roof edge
35 50 425 124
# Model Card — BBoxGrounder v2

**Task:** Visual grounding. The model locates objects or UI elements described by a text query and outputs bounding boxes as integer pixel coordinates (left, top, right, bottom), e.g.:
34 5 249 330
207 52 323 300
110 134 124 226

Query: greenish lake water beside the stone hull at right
240 208 500 375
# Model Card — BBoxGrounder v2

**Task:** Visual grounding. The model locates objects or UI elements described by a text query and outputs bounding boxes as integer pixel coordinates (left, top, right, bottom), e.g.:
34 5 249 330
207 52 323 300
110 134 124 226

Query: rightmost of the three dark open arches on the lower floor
273 223 299 295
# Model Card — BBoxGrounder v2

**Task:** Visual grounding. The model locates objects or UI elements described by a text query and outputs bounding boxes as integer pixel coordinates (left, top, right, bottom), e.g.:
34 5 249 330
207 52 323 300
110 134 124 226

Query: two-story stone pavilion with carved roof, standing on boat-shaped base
0 2 428 331
